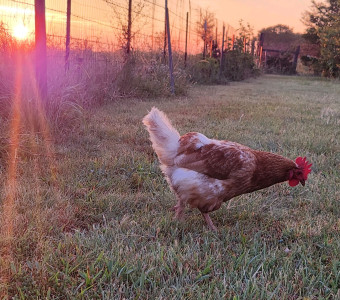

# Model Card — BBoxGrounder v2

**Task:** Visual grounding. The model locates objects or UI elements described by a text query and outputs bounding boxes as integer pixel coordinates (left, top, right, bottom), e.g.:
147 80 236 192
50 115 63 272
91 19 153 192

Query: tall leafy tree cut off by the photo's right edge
304 0 340 77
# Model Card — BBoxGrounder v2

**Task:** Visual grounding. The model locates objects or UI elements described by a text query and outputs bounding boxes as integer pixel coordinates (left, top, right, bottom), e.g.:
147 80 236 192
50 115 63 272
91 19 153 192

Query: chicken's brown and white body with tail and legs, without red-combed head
143 108 312 230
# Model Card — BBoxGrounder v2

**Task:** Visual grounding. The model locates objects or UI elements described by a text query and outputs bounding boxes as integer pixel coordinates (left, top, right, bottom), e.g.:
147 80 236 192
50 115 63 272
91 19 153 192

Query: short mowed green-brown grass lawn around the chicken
0 76 340 299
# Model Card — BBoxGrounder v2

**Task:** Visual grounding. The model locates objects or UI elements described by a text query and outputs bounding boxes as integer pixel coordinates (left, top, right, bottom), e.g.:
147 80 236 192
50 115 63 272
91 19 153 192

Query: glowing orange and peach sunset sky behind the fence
0 0 312 51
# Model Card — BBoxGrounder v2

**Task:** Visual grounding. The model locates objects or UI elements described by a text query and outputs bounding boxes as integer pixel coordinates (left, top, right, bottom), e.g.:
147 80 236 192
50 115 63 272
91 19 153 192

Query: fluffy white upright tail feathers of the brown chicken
143 107 180 166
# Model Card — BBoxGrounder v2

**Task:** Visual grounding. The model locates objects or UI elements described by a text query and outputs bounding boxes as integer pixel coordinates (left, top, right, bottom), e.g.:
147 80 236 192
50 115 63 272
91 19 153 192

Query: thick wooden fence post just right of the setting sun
34 0 47 104
